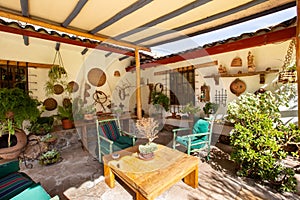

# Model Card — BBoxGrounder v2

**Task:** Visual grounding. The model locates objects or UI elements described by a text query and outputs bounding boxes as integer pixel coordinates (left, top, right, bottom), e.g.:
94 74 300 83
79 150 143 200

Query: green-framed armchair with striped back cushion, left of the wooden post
96 118 136 161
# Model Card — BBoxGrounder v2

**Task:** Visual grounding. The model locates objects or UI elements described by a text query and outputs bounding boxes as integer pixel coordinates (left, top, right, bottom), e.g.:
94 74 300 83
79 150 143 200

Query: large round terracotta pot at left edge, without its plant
0 130 27 160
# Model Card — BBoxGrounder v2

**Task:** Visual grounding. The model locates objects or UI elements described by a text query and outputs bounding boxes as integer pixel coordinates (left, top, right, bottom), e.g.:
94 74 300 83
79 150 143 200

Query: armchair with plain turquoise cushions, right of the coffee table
172 118 213 160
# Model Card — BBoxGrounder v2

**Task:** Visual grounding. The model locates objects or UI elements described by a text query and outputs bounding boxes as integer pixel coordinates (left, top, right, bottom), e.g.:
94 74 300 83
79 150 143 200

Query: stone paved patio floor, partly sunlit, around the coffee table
21 131 300 200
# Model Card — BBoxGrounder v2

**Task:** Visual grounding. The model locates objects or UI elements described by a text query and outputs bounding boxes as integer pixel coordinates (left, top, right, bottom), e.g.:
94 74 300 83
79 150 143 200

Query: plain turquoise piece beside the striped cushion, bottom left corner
12 183 51 200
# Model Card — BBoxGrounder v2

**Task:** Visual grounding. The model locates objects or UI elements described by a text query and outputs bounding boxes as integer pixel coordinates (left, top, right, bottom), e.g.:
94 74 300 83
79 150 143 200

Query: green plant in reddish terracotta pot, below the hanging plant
57 99 74 129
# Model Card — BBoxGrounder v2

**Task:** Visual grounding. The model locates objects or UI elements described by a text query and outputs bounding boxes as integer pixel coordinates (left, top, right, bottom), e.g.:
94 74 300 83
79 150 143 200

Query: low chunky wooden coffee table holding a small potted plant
103 145 199 200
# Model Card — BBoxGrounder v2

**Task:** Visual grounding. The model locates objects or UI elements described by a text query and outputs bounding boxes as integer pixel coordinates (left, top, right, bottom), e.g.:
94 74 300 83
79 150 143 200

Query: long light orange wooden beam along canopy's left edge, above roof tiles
0 11 150 51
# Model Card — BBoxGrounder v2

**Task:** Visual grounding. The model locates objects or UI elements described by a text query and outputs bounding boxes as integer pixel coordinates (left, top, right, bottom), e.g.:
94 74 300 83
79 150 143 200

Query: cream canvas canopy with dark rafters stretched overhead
0 0 296 49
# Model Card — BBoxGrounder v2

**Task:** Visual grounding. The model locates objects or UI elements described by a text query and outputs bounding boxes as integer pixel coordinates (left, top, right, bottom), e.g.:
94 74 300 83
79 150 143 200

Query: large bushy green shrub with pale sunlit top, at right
228 87 300 191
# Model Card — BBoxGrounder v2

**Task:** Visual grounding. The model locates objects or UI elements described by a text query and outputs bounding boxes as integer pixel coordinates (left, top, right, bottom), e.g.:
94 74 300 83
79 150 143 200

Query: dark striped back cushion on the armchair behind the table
100 120 120 141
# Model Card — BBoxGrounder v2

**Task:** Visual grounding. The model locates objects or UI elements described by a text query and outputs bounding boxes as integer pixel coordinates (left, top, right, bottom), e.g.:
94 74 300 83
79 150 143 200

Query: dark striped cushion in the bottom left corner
0 172 34 200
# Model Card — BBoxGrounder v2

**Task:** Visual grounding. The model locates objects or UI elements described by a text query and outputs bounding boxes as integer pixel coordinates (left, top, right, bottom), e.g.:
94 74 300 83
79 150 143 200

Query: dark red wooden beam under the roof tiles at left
0 25 134 56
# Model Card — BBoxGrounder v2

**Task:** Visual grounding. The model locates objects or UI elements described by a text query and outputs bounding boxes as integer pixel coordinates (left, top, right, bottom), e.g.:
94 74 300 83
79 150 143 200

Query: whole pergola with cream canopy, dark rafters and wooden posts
0 0 300 119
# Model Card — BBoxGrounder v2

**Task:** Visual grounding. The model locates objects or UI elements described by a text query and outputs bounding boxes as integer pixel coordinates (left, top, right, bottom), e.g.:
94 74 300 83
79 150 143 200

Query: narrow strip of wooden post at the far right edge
296 0 300 127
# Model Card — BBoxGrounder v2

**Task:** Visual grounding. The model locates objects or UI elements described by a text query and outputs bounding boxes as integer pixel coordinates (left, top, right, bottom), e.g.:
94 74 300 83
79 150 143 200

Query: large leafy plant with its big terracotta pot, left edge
0 88 40 159
